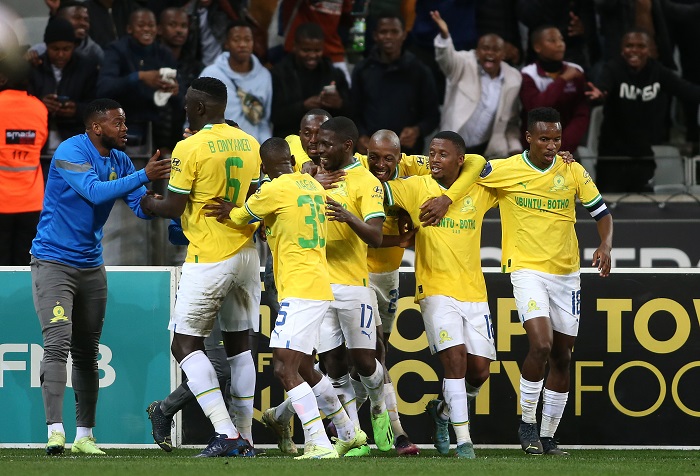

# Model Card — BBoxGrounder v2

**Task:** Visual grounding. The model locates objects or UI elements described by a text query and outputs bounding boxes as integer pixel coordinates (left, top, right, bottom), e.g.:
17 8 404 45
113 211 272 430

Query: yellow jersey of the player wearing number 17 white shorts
326 161 386 286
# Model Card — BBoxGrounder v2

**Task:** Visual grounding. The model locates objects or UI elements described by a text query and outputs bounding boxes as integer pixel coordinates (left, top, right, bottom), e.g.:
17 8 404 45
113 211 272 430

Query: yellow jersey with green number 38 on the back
230 172 333 301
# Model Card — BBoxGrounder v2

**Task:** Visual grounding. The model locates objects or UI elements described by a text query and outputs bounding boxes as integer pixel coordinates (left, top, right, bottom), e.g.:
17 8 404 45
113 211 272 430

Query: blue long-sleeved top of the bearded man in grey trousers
31 134 149 268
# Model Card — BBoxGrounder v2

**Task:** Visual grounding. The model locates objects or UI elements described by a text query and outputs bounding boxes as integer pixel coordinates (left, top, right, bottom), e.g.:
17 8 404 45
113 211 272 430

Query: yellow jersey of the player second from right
384 176 497 302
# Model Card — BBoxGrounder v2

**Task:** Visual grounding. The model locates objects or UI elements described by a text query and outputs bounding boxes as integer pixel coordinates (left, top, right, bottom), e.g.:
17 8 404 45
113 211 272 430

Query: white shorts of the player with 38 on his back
270 298 331 355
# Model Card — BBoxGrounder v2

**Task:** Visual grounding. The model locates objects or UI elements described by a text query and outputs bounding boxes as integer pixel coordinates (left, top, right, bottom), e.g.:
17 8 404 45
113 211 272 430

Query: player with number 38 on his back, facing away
205 137 341 459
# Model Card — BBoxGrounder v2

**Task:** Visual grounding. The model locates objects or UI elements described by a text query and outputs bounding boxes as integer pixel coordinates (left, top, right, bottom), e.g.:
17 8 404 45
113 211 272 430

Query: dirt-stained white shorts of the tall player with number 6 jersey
168 242 260 337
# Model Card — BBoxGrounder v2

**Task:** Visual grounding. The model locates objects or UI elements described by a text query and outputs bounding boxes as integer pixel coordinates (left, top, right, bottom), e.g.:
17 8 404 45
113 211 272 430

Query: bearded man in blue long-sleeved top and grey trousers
31 99 170 455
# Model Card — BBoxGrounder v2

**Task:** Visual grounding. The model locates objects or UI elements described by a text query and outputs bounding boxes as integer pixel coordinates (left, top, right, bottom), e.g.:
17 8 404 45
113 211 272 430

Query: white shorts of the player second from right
419 296 496 360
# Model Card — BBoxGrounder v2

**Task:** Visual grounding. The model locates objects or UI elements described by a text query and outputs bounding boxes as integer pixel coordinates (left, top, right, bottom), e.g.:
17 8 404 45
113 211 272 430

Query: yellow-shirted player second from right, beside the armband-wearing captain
384 131 496 458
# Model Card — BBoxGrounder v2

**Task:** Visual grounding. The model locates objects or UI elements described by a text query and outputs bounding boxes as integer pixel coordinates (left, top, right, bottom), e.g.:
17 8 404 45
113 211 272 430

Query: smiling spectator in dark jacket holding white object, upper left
97 8 181 149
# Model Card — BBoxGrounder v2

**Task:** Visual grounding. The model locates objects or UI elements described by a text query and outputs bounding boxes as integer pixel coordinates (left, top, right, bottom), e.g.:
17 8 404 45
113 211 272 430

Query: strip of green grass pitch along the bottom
0 447 700 476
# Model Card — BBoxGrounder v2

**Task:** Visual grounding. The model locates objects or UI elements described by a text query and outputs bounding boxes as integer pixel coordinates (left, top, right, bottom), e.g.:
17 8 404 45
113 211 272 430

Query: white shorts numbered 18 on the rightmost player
510 269 581 337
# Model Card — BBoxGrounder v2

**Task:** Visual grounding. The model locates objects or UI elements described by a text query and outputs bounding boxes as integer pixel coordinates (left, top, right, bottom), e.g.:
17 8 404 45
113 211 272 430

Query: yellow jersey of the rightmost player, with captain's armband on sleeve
478 151 609 275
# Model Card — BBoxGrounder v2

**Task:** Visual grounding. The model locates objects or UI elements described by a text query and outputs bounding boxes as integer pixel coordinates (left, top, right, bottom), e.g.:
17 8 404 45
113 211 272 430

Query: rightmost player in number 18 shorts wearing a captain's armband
479 108 613 455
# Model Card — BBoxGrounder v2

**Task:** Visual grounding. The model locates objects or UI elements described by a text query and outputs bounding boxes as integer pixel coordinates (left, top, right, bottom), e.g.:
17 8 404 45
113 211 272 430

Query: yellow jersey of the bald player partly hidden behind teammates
355 153 486 273
